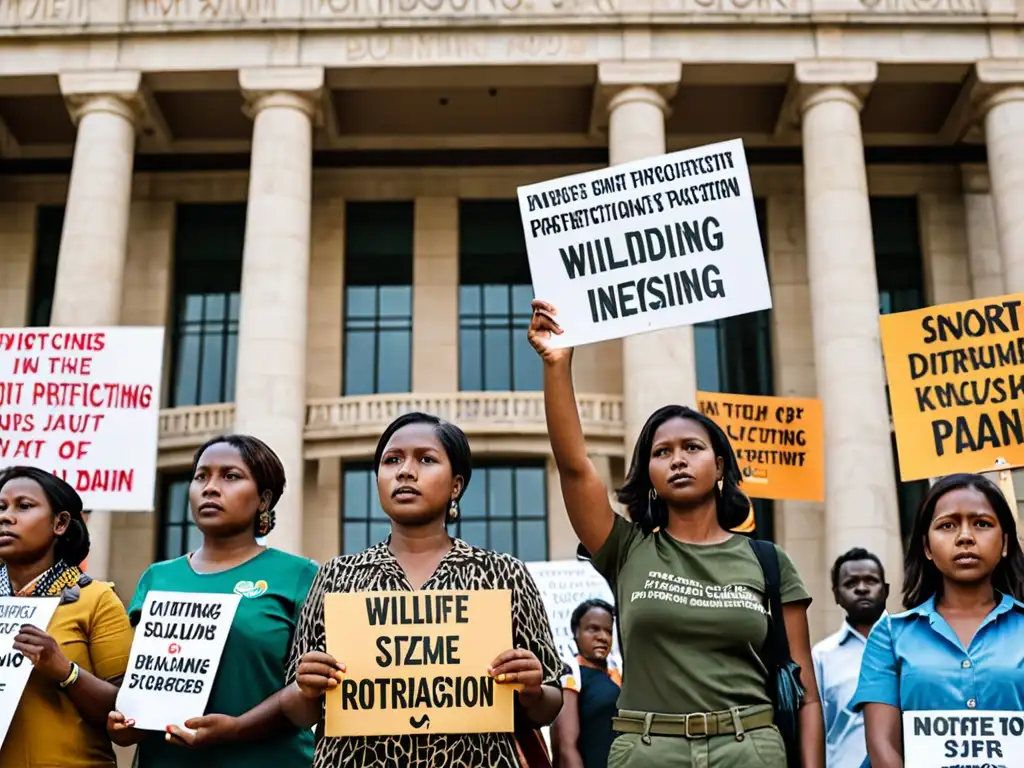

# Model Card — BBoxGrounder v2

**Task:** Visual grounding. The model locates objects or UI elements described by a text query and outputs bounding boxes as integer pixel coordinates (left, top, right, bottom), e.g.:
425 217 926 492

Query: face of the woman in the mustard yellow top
0 477 71 564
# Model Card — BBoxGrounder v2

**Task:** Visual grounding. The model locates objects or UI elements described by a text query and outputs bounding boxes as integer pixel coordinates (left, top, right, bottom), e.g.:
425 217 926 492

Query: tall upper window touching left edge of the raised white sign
459 200 542 391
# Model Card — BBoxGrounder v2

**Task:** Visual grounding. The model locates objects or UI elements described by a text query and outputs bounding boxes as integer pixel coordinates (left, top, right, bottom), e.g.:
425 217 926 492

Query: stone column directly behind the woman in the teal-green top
234 68 324 553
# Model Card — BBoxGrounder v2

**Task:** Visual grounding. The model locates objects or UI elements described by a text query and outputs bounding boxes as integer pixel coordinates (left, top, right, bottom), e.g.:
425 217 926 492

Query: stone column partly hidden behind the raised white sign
598 61 697 454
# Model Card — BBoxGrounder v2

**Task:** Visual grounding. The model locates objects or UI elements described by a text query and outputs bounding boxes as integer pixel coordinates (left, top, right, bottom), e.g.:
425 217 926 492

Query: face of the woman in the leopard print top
377 424 463 525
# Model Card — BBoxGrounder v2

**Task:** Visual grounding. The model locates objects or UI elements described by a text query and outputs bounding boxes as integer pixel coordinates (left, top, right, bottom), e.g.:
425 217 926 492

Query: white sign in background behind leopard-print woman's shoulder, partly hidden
526 560 620 662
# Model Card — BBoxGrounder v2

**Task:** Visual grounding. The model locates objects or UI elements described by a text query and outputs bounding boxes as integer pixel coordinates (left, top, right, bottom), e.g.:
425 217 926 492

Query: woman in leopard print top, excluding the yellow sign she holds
279 414 562 768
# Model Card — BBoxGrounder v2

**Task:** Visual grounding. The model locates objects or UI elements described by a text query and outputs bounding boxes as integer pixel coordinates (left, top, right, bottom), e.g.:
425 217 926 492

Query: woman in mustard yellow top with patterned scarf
0 467 132 768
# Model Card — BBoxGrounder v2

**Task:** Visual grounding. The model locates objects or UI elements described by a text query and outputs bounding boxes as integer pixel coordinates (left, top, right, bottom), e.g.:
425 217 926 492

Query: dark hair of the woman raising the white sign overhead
615 406 751 534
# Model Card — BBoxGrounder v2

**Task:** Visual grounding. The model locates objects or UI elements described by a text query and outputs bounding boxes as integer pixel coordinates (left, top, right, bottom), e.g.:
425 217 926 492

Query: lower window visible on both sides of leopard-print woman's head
341 461 548 561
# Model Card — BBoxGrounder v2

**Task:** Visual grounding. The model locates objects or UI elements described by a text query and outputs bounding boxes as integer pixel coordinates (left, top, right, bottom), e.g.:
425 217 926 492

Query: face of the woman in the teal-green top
188 442 270 537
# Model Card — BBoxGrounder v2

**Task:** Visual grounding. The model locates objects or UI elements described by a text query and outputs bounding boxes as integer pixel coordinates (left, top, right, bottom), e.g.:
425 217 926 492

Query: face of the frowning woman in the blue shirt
925 488 1007 584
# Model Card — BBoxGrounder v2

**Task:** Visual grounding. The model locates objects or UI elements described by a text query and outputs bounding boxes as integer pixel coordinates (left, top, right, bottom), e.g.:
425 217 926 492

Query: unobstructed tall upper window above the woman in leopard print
343 203 413 395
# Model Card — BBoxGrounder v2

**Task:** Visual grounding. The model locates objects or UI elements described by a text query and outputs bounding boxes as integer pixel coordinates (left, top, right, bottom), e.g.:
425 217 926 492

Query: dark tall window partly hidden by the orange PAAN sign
870 198 928 548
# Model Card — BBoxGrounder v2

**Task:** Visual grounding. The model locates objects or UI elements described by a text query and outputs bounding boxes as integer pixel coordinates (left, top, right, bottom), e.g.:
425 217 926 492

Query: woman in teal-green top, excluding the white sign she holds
108 435 316 768
